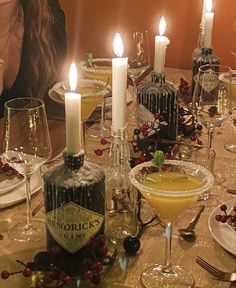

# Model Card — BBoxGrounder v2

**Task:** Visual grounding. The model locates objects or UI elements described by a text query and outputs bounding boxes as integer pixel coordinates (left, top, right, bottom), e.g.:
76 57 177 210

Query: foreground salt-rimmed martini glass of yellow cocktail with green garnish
129 160 214 288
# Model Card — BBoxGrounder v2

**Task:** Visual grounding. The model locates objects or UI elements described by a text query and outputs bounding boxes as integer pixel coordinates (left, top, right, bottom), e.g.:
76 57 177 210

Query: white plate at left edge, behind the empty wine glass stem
0 171 42 208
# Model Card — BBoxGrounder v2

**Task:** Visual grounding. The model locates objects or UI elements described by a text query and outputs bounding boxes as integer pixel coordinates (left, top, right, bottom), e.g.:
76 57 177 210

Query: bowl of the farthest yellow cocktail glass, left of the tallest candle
79 58 112 86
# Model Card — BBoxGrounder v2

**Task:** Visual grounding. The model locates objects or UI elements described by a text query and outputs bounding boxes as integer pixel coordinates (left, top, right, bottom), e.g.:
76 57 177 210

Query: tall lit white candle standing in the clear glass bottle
112 33 128 131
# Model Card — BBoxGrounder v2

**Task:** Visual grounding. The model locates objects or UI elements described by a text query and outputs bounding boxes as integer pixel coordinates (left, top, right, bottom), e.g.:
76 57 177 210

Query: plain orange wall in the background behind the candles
60 0 236 68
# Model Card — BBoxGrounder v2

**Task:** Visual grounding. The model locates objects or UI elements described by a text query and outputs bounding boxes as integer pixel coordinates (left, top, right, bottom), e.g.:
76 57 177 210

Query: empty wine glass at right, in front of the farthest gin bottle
193 64 232 151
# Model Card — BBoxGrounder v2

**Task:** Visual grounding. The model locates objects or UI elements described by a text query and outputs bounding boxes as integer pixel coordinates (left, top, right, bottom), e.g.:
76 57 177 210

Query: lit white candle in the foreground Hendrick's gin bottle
65 62 81 155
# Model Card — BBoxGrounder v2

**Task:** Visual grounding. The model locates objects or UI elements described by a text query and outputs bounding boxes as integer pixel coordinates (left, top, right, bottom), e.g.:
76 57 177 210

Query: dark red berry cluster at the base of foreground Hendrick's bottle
1 234 114 288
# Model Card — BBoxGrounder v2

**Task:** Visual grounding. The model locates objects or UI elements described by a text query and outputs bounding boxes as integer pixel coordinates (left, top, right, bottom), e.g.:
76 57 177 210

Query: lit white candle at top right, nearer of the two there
204 0 214 48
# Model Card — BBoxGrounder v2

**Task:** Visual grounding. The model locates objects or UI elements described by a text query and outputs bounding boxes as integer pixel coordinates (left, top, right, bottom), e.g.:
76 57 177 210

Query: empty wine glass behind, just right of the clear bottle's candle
124 29 150 124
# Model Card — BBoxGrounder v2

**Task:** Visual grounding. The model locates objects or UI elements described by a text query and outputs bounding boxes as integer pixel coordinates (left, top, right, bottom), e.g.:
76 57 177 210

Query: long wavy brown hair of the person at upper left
20 0 65 98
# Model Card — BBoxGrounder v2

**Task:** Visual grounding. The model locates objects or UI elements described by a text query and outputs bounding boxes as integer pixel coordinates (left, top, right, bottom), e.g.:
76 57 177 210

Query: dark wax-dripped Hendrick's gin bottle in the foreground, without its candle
43 152 105 267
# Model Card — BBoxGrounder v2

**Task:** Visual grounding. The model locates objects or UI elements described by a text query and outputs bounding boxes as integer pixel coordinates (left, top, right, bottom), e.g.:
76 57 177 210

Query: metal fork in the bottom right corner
196 256 236 282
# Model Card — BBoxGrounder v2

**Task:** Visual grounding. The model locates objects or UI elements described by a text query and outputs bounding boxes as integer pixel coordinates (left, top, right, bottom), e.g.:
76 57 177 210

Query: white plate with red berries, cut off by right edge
208 198 236 256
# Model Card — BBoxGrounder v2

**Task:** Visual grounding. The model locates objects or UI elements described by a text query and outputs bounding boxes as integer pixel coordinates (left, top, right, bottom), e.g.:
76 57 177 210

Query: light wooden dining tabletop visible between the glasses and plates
0 68 236 288
